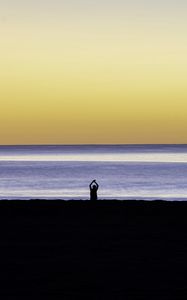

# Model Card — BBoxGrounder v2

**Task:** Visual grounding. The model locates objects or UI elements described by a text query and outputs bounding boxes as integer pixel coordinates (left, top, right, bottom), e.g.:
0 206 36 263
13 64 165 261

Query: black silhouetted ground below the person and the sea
0 200 187 300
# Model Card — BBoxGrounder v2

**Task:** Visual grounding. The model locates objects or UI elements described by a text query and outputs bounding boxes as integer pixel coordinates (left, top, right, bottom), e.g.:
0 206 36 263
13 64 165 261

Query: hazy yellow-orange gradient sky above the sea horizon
0 0 187 145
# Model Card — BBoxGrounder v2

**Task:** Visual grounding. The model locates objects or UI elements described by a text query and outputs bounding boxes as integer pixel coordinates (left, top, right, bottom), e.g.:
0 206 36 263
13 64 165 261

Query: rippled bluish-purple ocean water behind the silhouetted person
0 145 187 200
